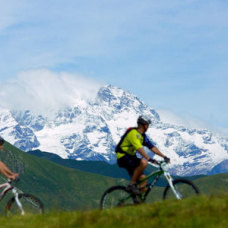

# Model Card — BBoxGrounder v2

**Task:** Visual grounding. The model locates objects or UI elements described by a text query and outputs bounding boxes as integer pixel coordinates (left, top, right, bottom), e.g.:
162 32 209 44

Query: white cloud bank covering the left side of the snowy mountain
0 69 102 114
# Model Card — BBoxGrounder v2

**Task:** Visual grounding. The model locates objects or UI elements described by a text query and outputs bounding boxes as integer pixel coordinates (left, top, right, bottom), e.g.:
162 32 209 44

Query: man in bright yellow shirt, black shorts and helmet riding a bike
116 116 170 194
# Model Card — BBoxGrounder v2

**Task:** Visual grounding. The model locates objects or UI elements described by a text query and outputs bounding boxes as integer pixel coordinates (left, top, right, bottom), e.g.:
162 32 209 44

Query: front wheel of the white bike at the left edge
5 193 44 216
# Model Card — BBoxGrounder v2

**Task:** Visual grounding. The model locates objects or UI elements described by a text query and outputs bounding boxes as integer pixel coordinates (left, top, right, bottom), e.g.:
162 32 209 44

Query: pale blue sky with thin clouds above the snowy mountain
0 0 228 135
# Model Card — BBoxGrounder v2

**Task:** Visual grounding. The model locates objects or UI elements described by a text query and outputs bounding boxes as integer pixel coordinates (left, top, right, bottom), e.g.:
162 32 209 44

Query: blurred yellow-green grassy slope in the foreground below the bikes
0 194 228 228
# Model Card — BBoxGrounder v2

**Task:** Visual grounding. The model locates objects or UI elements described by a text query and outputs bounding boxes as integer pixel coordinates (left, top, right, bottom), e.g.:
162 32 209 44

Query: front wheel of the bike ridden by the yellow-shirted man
163 179 199 200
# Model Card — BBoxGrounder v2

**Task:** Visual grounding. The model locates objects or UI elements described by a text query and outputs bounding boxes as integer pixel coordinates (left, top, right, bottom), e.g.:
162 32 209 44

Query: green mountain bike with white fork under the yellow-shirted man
100 161 199 209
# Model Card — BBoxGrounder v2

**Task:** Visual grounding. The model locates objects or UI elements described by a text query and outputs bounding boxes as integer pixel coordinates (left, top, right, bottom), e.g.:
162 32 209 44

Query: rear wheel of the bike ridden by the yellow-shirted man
100 186 138 210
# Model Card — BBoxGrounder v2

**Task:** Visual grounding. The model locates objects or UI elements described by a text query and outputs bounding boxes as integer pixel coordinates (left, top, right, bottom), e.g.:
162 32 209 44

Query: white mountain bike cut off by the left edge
0 178 44 216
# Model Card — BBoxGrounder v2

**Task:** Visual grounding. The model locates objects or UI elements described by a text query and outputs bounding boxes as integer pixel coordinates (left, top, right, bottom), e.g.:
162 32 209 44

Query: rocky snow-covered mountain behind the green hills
0 86 228 175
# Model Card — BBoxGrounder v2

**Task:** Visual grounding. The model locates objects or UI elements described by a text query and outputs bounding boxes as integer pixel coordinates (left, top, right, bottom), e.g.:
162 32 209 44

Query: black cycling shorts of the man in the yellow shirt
117 154 141 176
